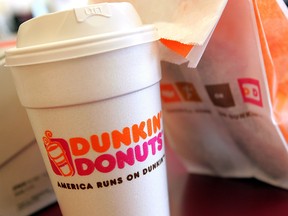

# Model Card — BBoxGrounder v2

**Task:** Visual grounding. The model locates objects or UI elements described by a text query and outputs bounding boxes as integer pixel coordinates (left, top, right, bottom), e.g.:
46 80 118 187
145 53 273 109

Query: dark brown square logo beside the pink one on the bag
205 84 235 108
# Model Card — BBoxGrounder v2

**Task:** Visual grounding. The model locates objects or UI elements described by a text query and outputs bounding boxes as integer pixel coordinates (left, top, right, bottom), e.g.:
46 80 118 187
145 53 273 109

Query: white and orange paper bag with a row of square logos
161 0 288 188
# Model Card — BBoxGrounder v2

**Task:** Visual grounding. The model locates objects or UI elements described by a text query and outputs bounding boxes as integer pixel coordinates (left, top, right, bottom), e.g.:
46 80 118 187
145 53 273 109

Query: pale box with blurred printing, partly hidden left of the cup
0 45 56 216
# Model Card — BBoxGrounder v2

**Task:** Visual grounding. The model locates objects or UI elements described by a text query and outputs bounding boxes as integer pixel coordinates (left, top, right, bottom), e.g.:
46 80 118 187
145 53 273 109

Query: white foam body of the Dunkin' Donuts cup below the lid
7 42 169 216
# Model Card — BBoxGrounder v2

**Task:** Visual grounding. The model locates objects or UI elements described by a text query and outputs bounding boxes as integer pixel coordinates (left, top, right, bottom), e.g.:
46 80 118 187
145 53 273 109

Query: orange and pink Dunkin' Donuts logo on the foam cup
43 112 163 177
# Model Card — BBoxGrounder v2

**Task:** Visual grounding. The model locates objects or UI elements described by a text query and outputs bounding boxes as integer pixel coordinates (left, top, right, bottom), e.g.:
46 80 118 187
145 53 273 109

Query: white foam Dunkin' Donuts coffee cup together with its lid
6 3 169 216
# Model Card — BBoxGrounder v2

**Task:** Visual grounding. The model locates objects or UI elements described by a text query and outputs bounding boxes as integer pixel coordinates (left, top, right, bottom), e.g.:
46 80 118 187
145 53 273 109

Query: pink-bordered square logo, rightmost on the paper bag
238 78 263 107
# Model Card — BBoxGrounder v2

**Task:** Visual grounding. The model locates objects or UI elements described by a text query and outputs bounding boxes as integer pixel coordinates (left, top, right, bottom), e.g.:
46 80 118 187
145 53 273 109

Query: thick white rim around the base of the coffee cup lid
5 25 159 66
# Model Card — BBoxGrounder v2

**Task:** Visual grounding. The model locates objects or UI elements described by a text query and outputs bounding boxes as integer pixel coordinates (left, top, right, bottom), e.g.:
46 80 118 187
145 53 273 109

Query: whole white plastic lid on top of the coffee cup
6 2 159 66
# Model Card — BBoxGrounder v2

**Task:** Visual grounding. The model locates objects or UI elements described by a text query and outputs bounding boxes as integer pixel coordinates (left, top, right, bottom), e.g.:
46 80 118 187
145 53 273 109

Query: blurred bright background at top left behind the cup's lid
0 0 288 41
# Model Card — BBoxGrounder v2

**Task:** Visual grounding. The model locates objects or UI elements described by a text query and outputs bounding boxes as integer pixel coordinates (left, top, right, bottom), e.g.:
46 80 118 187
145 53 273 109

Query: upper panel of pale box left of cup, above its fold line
0 52 35 167
